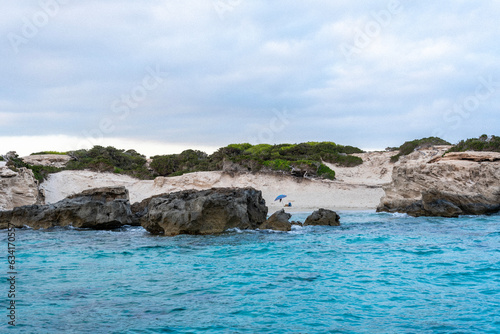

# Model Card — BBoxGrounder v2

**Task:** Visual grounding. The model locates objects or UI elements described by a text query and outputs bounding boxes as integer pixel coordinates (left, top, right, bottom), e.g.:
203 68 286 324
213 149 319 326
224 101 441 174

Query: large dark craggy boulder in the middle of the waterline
140 188 267 236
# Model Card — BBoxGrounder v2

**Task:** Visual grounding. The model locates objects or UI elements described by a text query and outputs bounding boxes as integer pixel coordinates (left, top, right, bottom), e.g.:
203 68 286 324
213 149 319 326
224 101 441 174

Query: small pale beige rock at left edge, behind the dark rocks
0 167 43 210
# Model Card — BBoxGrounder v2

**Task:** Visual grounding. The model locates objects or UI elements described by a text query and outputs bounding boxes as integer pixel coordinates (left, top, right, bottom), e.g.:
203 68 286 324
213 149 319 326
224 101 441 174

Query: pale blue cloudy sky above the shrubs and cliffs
0 0 500 156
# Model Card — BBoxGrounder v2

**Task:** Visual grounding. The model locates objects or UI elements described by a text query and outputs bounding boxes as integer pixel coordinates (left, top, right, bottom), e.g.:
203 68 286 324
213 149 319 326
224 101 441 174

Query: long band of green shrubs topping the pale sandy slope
2 142 363 182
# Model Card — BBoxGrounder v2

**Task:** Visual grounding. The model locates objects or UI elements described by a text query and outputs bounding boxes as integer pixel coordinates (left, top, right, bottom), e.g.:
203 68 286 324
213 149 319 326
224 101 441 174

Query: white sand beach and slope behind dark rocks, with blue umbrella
41 152 394 212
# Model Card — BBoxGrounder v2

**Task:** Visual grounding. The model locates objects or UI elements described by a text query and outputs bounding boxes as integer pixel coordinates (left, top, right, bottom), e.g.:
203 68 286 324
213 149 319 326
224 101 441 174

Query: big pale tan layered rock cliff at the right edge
377 152 500 217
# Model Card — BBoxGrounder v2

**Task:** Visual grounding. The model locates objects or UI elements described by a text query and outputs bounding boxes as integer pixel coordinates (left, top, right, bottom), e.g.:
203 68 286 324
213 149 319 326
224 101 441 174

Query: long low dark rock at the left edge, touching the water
0 187 132 230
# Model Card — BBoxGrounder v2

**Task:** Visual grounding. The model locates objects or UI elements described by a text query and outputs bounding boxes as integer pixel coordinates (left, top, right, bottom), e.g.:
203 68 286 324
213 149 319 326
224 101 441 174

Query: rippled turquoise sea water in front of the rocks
0 211 500 333
